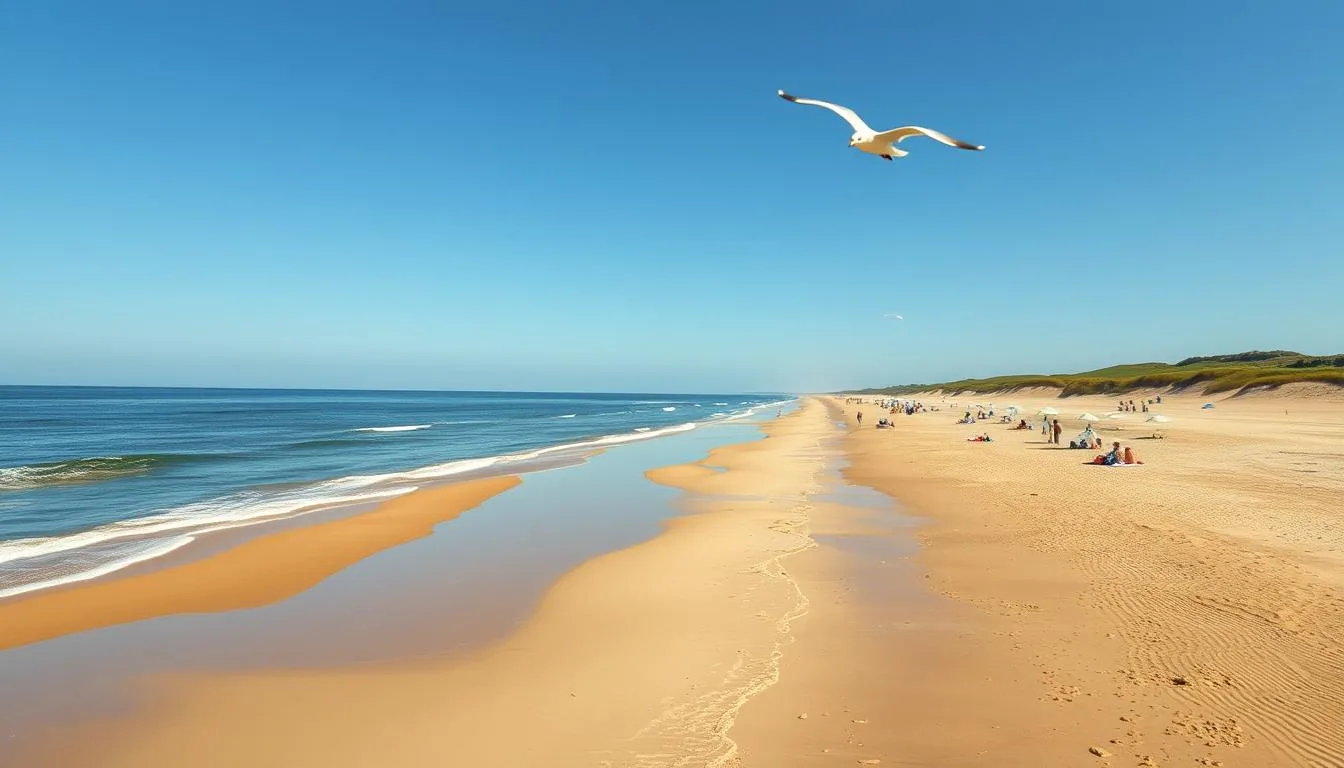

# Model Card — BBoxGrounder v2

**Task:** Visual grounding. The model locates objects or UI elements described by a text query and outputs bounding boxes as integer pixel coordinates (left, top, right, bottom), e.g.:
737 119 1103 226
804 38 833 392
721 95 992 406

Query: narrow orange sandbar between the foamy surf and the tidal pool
0 476 519 650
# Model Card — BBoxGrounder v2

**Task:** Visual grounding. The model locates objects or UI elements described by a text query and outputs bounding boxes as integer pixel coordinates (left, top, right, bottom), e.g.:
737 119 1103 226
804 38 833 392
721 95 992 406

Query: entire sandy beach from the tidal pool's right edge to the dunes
10 390 1344 767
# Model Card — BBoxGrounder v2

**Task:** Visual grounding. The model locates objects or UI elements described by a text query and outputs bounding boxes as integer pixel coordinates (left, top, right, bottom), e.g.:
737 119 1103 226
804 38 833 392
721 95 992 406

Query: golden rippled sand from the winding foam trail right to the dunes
737 389 1344 768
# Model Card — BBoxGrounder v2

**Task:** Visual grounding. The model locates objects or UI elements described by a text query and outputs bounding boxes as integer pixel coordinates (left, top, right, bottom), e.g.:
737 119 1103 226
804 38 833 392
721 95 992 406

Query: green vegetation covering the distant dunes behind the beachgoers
859 350 1344 397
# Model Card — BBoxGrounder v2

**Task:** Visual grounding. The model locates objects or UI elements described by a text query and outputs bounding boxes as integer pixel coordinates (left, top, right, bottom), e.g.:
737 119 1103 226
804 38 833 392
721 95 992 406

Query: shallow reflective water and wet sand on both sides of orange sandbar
0 420 779 765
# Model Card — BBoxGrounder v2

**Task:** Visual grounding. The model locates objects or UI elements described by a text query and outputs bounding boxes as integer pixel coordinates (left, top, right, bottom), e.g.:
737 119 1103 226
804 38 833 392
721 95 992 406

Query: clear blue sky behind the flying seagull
0 0 1344 391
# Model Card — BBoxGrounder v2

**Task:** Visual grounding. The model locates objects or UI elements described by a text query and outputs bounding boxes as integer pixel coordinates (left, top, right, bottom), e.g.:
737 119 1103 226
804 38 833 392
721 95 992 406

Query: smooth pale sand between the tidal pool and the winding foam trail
24 405 833 767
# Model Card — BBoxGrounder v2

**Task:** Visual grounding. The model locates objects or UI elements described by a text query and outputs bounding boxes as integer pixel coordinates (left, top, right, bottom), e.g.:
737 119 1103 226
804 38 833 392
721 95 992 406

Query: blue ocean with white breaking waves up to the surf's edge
0 387 781 597
